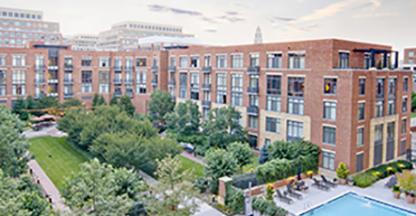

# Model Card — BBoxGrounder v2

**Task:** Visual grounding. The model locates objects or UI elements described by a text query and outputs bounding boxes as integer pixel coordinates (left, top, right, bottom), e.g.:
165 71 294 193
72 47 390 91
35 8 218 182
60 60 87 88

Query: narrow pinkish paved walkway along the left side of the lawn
28 160 69 213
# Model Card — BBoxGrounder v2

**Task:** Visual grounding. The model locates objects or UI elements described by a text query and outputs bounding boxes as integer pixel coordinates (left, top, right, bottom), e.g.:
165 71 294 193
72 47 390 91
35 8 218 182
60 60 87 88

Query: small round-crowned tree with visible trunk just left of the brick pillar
205 149 238 193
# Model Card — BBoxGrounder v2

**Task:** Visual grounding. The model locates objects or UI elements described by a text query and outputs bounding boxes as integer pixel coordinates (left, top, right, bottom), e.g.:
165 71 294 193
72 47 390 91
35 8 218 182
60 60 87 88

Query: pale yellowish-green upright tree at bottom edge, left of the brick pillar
147 156 197 216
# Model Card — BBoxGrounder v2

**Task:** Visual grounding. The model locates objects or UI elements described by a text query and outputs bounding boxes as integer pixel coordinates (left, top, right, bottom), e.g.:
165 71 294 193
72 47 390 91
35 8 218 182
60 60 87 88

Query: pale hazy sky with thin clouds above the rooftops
0 0 416 54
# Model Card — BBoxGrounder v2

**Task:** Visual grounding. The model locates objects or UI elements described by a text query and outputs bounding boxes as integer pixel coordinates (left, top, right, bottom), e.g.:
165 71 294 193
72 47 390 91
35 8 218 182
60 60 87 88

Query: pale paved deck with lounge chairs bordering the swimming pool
274 178 416 215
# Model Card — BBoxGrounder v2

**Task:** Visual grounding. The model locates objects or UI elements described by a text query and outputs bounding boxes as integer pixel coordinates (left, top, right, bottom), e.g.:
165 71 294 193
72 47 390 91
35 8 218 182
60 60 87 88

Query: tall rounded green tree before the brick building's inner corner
149 90 175 128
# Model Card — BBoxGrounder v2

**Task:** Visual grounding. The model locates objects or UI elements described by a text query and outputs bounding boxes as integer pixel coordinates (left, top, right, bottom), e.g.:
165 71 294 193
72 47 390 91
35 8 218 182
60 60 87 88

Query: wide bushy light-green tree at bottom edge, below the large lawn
63 159 145 215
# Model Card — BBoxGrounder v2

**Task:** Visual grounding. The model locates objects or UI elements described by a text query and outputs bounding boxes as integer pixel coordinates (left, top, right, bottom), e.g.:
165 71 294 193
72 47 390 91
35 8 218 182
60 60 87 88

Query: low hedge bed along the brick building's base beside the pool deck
353 160 413 188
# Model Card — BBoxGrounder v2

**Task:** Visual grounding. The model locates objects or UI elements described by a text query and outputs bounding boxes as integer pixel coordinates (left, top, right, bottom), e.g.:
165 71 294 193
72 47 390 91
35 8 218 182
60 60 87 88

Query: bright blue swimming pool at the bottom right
301 193 416 216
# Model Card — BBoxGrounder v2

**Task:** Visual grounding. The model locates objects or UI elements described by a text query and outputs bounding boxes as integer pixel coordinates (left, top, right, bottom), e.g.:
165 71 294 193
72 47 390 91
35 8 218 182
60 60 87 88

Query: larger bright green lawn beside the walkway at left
29 137 89 192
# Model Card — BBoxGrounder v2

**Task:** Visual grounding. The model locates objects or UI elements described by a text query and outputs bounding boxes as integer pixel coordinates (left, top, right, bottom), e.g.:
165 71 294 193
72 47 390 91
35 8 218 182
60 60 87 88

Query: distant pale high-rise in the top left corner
0 7 62 47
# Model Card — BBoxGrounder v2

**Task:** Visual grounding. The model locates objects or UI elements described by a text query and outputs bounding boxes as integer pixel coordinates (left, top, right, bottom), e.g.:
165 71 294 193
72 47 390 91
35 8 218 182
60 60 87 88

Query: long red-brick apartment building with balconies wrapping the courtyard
0 39 412 172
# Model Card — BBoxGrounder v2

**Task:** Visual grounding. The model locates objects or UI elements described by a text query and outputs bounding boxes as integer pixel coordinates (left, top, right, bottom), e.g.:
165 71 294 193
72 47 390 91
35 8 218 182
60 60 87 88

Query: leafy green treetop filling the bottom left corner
0 169 52 216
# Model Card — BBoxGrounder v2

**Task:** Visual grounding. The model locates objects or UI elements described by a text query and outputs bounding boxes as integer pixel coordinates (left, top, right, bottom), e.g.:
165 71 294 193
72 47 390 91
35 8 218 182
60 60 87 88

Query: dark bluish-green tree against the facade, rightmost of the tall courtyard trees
203 107 247 148
